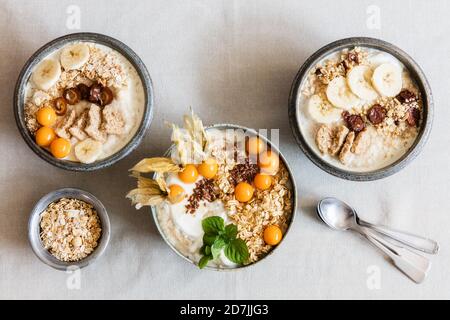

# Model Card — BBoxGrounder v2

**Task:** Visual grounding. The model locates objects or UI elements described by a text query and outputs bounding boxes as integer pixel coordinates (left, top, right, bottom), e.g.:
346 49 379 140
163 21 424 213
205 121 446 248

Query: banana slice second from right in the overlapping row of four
347 66 378 101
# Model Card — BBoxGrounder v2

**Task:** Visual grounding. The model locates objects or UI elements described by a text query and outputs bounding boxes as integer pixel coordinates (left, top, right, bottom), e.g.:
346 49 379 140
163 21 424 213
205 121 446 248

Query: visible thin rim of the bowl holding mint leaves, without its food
151 124 297 271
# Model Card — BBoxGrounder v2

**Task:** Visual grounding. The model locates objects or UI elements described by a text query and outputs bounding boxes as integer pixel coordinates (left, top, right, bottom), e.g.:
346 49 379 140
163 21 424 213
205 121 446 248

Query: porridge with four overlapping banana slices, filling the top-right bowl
297 47 422 172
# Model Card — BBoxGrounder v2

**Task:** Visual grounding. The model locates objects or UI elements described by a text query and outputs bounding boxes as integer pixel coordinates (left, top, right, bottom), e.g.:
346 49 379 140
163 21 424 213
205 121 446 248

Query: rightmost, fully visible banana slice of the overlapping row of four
372 63 403 97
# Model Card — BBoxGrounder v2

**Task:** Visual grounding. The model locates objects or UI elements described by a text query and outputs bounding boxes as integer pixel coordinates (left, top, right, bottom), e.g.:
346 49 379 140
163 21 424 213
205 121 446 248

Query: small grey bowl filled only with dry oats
28 188 110 271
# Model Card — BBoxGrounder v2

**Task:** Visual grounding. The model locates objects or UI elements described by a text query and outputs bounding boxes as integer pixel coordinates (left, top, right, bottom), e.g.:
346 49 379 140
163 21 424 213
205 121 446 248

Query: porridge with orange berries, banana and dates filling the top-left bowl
25 42 145 163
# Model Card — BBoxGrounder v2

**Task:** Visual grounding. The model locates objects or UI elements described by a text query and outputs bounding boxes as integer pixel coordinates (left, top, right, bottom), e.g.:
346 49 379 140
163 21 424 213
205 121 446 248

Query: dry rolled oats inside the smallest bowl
40 198 102 261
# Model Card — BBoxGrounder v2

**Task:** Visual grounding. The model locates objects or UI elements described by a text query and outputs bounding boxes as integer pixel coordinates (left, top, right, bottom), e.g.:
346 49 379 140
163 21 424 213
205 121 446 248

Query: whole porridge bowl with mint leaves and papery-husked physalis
128 115 297 270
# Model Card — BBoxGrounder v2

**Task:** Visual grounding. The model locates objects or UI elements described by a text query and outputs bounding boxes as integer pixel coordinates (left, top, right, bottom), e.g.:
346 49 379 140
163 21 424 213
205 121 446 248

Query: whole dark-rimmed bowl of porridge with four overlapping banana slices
289 38 433 181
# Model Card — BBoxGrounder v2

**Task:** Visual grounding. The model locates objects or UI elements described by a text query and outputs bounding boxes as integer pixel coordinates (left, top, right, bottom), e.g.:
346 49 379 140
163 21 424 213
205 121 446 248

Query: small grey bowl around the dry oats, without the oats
28 188 111 271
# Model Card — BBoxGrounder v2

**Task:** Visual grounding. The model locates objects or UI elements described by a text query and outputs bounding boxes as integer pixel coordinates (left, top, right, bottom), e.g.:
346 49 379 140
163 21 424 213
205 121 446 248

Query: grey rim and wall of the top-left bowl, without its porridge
14 32 153 171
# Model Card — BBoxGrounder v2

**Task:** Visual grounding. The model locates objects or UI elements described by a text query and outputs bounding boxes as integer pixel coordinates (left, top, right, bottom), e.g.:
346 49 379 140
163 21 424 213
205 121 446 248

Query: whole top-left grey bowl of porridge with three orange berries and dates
14 33 153 171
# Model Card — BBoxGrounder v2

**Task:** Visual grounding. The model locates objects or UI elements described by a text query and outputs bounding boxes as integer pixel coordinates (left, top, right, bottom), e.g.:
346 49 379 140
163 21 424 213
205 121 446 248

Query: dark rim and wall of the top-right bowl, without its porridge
289 37 433 181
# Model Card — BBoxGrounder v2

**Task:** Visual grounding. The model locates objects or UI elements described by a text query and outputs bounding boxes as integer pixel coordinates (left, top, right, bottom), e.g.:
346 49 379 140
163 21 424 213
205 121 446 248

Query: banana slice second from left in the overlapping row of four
326 77 359 110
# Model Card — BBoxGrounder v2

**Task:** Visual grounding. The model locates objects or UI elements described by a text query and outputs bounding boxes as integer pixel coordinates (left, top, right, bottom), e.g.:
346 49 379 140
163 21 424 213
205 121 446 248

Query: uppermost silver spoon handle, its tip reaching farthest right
358 219 439 254
